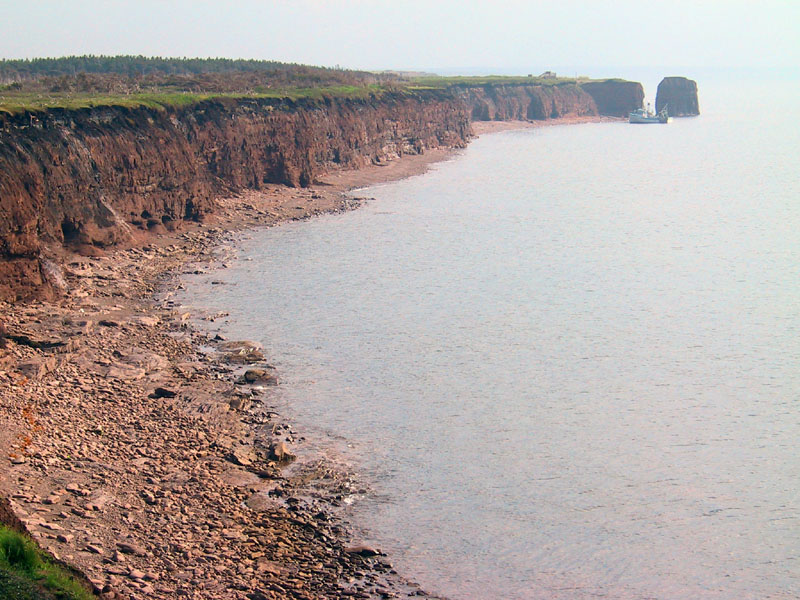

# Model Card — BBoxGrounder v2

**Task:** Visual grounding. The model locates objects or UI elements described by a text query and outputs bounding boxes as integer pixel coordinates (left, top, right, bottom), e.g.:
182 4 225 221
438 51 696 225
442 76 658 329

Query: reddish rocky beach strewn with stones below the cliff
0 117 600 600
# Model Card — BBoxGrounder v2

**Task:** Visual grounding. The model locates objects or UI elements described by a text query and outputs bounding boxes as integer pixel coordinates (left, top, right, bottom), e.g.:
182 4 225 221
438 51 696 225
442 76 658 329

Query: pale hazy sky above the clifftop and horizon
0 0 800 73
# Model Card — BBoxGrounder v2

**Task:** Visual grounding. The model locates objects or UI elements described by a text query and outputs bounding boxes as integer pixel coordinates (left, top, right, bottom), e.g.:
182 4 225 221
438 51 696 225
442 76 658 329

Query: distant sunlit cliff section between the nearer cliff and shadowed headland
460 84 599 121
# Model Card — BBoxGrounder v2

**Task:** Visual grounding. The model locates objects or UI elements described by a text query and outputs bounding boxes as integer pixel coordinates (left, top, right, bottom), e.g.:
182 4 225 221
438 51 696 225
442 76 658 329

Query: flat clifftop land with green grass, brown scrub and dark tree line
0 56 628 114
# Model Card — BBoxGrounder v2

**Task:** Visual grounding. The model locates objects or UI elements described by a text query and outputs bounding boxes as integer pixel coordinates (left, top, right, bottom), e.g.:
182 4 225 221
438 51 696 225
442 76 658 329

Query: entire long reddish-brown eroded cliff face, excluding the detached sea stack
0 81 641 300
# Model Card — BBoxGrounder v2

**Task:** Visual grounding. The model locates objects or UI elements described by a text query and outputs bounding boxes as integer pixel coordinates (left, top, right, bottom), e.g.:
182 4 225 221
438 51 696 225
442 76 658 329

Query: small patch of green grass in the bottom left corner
0 526 94 600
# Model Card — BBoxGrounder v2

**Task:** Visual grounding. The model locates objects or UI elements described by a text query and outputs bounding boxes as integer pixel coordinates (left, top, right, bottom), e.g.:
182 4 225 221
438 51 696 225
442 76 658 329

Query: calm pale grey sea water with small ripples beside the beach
185 83 800 600
